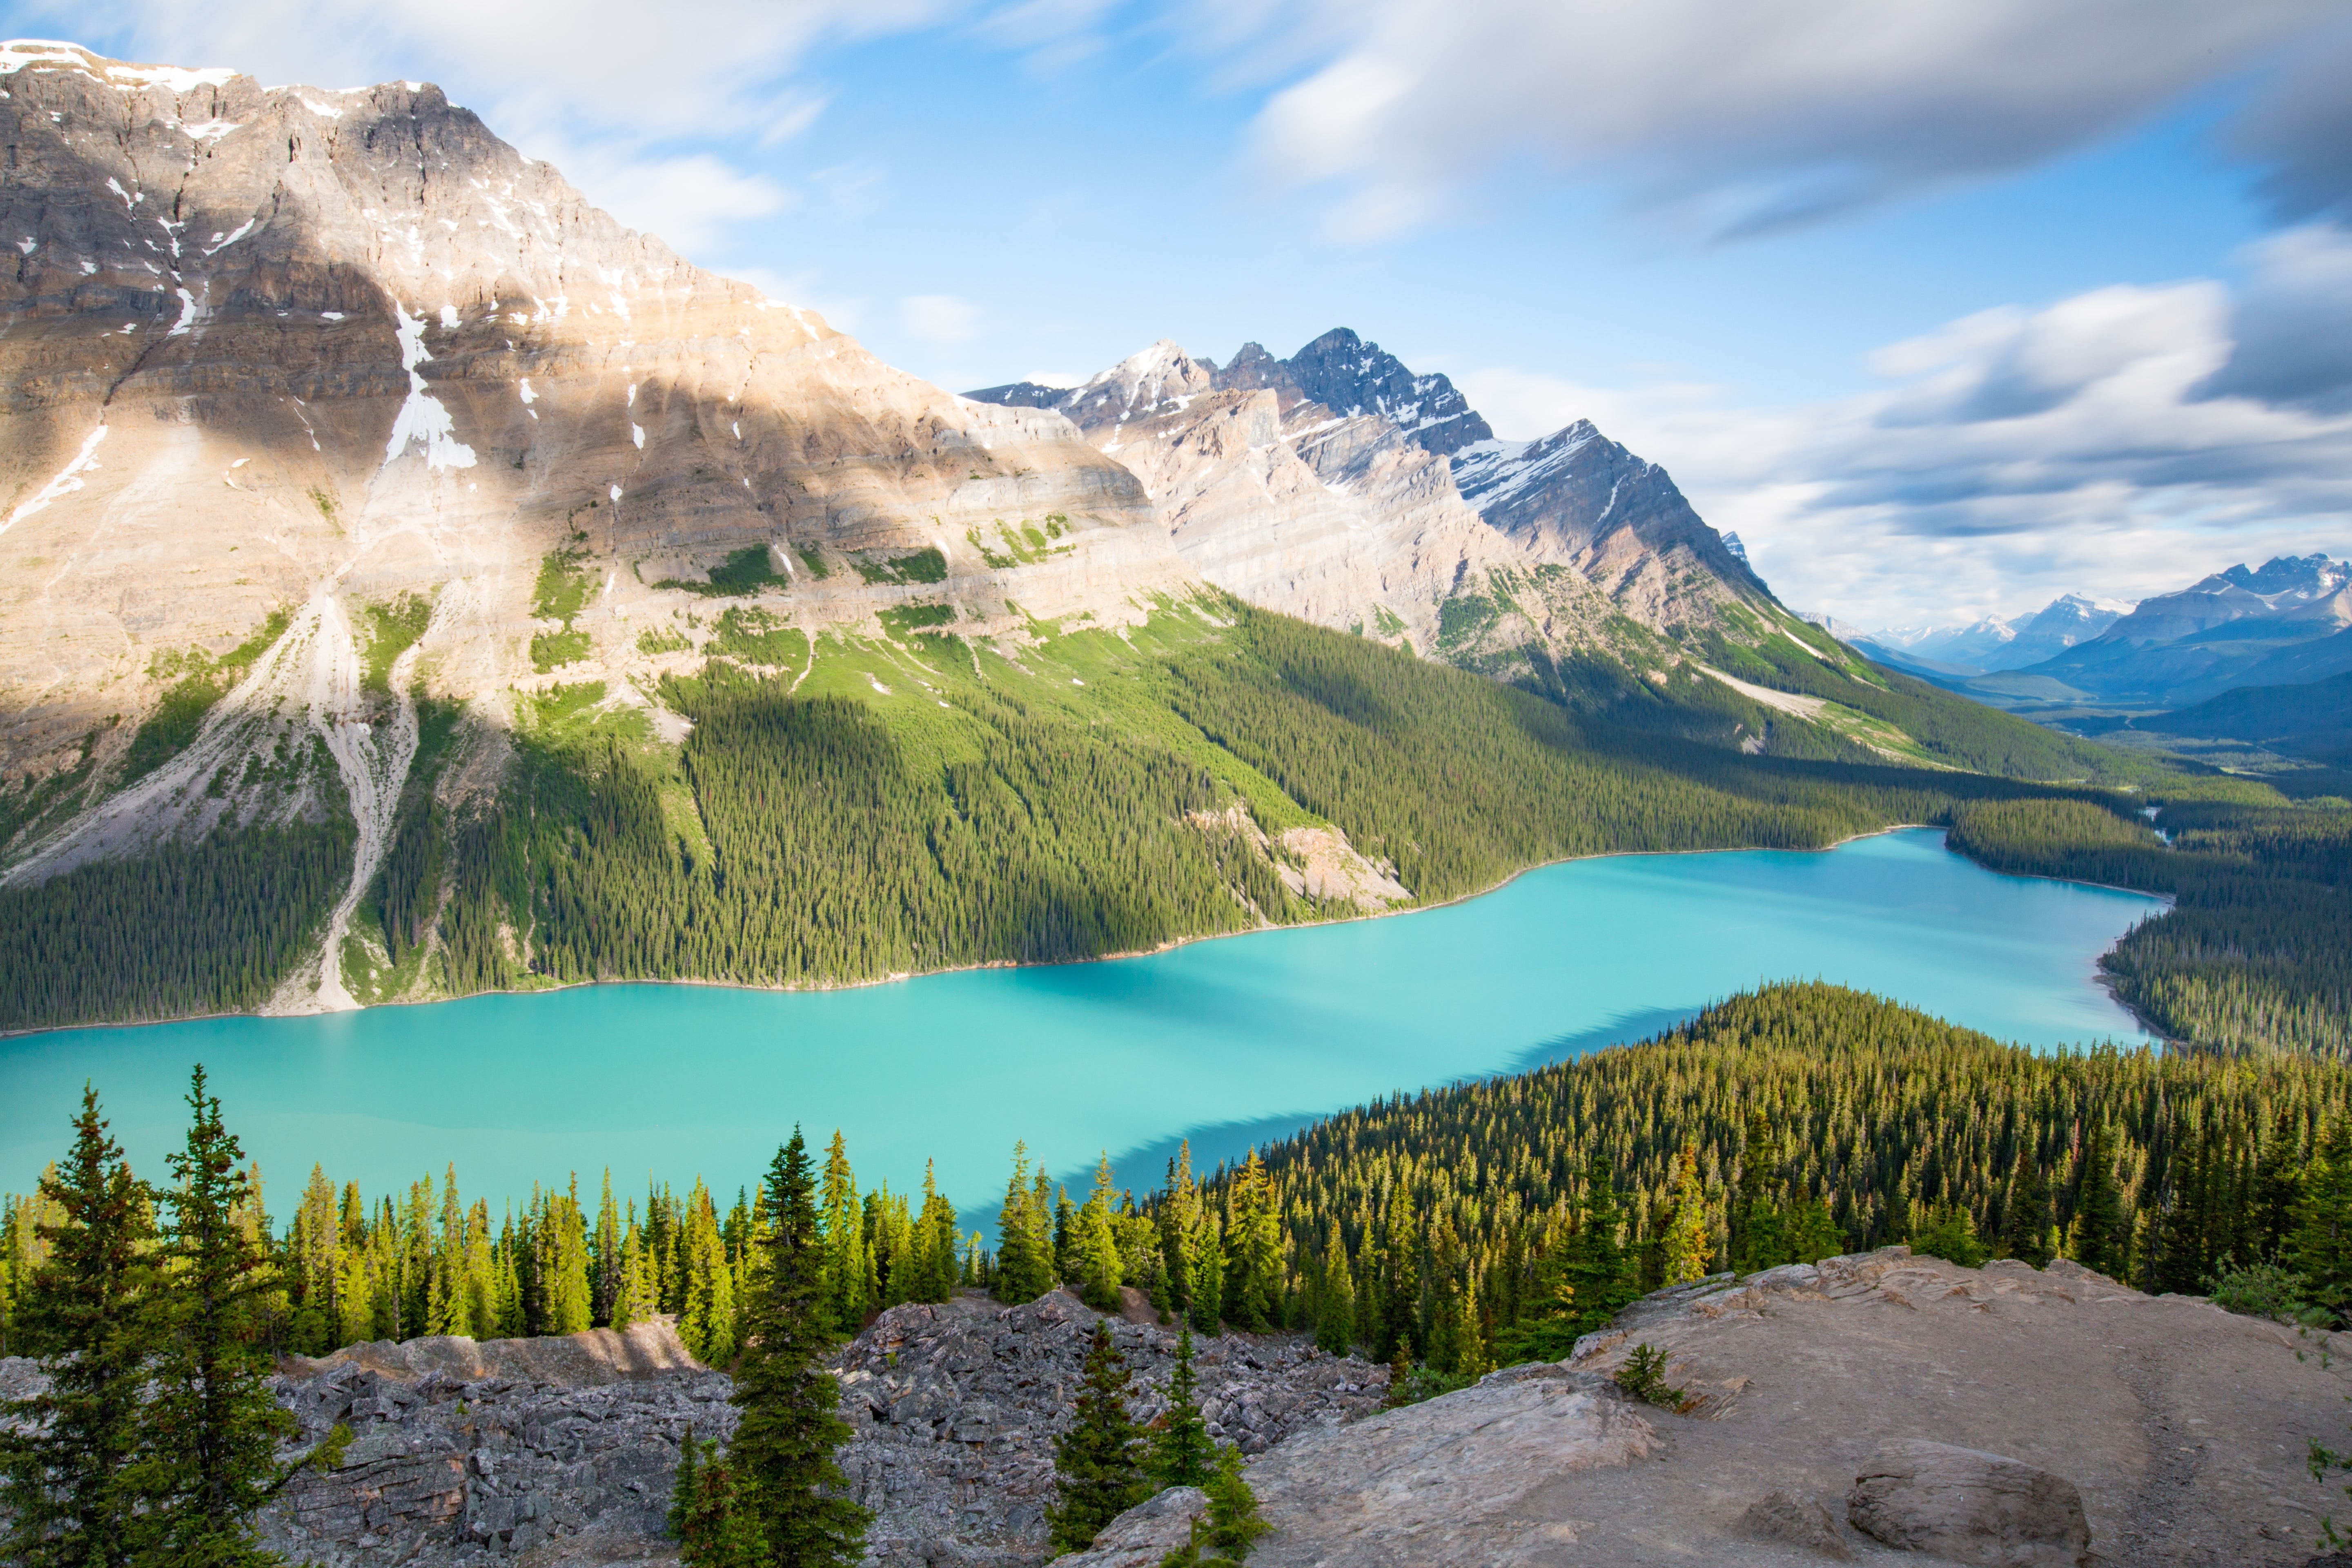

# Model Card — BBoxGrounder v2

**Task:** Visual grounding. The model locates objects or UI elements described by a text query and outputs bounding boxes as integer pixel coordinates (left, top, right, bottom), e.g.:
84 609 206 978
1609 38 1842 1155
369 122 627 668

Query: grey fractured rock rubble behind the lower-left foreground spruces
0 1291 1388 1568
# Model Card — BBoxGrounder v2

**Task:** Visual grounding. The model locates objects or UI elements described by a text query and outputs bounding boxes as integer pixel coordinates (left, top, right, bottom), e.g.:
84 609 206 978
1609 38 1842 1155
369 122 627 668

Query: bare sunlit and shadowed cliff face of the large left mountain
0 42 1176 879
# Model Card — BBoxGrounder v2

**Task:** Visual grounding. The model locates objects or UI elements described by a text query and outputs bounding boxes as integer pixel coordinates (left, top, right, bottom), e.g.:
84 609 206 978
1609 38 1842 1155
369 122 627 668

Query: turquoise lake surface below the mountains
0 828 2161 1223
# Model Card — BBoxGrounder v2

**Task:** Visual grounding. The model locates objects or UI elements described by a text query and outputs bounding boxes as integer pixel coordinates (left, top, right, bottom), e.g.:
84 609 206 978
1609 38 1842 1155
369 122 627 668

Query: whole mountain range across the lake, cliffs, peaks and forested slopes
0 42 2154 1030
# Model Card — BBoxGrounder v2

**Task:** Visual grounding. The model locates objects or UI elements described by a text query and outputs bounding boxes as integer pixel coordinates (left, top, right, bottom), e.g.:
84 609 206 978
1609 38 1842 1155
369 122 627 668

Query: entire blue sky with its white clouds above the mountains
18 0 2352 625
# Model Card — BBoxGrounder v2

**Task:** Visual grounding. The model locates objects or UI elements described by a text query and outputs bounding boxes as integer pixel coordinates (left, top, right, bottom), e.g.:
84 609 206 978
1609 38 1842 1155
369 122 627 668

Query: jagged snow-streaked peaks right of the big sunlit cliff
967 327 1788 679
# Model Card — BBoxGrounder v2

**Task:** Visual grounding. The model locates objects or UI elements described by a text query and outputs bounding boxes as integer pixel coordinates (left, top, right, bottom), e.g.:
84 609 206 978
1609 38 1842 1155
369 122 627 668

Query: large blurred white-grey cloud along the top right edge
1242 0 2343 237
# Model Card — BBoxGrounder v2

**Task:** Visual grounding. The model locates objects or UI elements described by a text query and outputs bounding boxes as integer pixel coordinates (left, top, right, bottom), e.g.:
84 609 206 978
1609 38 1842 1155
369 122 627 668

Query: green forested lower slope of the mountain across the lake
0 602 2107 1027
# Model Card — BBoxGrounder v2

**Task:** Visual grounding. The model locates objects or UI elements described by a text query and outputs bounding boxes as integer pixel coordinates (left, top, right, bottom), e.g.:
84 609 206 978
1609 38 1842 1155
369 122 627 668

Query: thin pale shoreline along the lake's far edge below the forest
0 823 2173 1041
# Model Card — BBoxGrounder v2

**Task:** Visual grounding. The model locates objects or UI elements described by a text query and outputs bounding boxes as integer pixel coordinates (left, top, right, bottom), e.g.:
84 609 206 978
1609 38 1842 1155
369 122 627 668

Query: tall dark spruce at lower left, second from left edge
143 1067 350 1568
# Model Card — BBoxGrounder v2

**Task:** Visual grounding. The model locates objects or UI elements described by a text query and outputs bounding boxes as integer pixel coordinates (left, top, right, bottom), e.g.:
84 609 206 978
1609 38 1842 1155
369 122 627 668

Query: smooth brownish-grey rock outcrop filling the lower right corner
1065 1246 2352 1568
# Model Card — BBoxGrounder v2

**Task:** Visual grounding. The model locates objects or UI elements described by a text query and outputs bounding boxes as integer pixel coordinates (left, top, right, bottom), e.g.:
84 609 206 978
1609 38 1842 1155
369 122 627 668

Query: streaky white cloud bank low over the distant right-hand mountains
1461 230 2352 625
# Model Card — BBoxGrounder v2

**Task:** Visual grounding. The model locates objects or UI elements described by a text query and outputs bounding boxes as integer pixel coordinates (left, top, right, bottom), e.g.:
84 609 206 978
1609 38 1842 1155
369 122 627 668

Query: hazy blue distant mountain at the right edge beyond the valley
2013 555 2352 708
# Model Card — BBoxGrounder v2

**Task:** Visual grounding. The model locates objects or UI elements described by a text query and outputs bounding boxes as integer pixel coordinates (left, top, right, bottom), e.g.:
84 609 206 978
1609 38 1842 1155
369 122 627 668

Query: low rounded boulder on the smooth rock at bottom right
1846 1441 2091 1568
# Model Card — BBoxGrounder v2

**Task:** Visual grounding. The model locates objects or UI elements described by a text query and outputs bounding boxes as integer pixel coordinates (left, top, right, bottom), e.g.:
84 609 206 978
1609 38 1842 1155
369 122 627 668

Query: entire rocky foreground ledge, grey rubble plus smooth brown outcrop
0 1248 2352 1568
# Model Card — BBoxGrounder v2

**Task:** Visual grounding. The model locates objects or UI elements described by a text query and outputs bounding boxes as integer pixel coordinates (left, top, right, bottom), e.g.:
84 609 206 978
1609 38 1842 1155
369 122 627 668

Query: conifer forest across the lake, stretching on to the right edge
0 602 2352 1053
